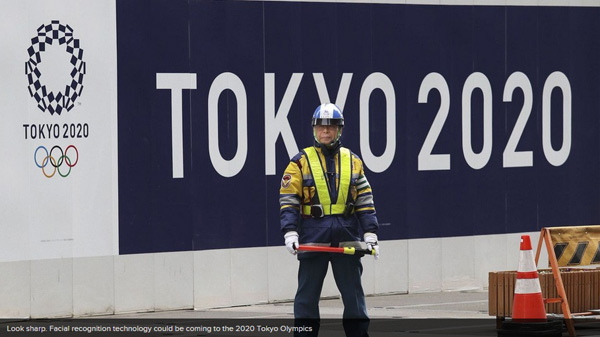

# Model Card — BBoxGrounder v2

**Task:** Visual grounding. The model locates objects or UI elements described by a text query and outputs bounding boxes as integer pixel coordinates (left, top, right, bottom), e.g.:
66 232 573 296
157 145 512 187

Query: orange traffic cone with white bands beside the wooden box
512 235 546 322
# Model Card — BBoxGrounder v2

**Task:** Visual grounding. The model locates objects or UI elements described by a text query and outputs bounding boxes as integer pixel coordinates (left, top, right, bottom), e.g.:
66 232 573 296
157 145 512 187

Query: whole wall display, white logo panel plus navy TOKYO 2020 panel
0 0 600 261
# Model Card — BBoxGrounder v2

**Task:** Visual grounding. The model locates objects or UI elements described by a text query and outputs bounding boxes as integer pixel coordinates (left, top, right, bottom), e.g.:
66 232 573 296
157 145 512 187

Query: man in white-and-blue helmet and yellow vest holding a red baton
279 103 379 337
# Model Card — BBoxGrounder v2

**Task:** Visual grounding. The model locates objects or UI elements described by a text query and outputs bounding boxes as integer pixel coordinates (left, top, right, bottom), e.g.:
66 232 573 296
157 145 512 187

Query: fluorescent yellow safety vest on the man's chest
302 146 352 215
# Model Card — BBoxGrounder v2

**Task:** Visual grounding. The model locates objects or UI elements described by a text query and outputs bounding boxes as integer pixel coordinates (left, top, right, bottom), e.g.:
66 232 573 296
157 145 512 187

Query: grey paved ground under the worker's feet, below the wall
0 291 600 337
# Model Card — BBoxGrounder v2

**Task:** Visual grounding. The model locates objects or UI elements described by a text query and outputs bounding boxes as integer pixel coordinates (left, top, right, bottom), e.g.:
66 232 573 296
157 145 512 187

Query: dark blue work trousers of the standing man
294 253 369 337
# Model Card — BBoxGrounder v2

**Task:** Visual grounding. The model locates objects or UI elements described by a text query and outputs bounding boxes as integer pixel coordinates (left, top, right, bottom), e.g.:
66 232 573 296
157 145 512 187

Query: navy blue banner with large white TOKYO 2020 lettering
116 0 600 254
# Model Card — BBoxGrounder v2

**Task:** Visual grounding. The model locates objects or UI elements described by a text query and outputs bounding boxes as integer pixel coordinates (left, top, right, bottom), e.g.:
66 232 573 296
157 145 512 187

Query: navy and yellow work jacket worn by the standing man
279 142 379 258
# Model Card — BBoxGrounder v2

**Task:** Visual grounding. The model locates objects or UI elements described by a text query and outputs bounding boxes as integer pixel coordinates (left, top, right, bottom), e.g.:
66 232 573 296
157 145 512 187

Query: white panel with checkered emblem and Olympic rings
0 0 118 262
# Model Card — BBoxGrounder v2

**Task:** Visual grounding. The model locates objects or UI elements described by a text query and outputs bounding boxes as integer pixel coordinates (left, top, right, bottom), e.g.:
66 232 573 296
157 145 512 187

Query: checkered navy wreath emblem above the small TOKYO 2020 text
25 20 85 115
